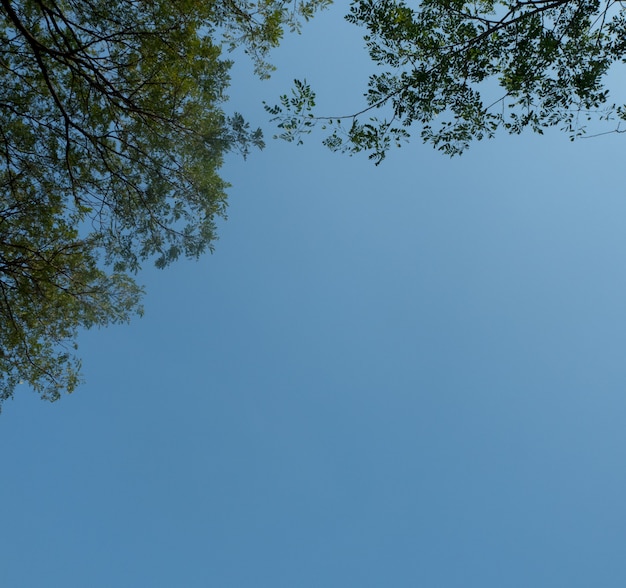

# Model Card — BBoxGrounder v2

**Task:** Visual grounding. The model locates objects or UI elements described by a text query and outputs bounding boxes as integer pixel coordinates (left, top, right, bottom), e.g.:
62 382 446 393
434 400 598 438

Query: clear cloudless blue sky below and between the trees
0 3 626 588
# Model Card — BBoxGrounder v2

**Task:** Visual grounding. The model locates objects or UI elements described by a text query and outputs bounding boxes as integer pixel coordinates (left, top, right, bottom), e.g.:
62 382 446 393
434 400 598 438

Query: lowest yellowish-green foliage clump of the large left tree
0 193 142 402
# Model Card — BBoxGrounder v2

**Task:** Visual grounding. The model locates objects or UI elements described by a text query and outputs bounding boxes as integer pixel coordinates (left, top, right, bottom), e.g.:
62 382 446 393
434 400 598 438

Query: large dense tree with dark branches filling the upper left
0 0 329 402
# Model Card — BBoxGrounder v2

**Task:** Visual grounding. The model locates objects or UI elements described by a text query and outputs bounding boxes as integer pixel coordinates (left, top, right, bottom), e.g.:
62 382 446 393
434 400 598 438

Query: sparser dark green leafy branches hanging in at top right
266 0 626 163
